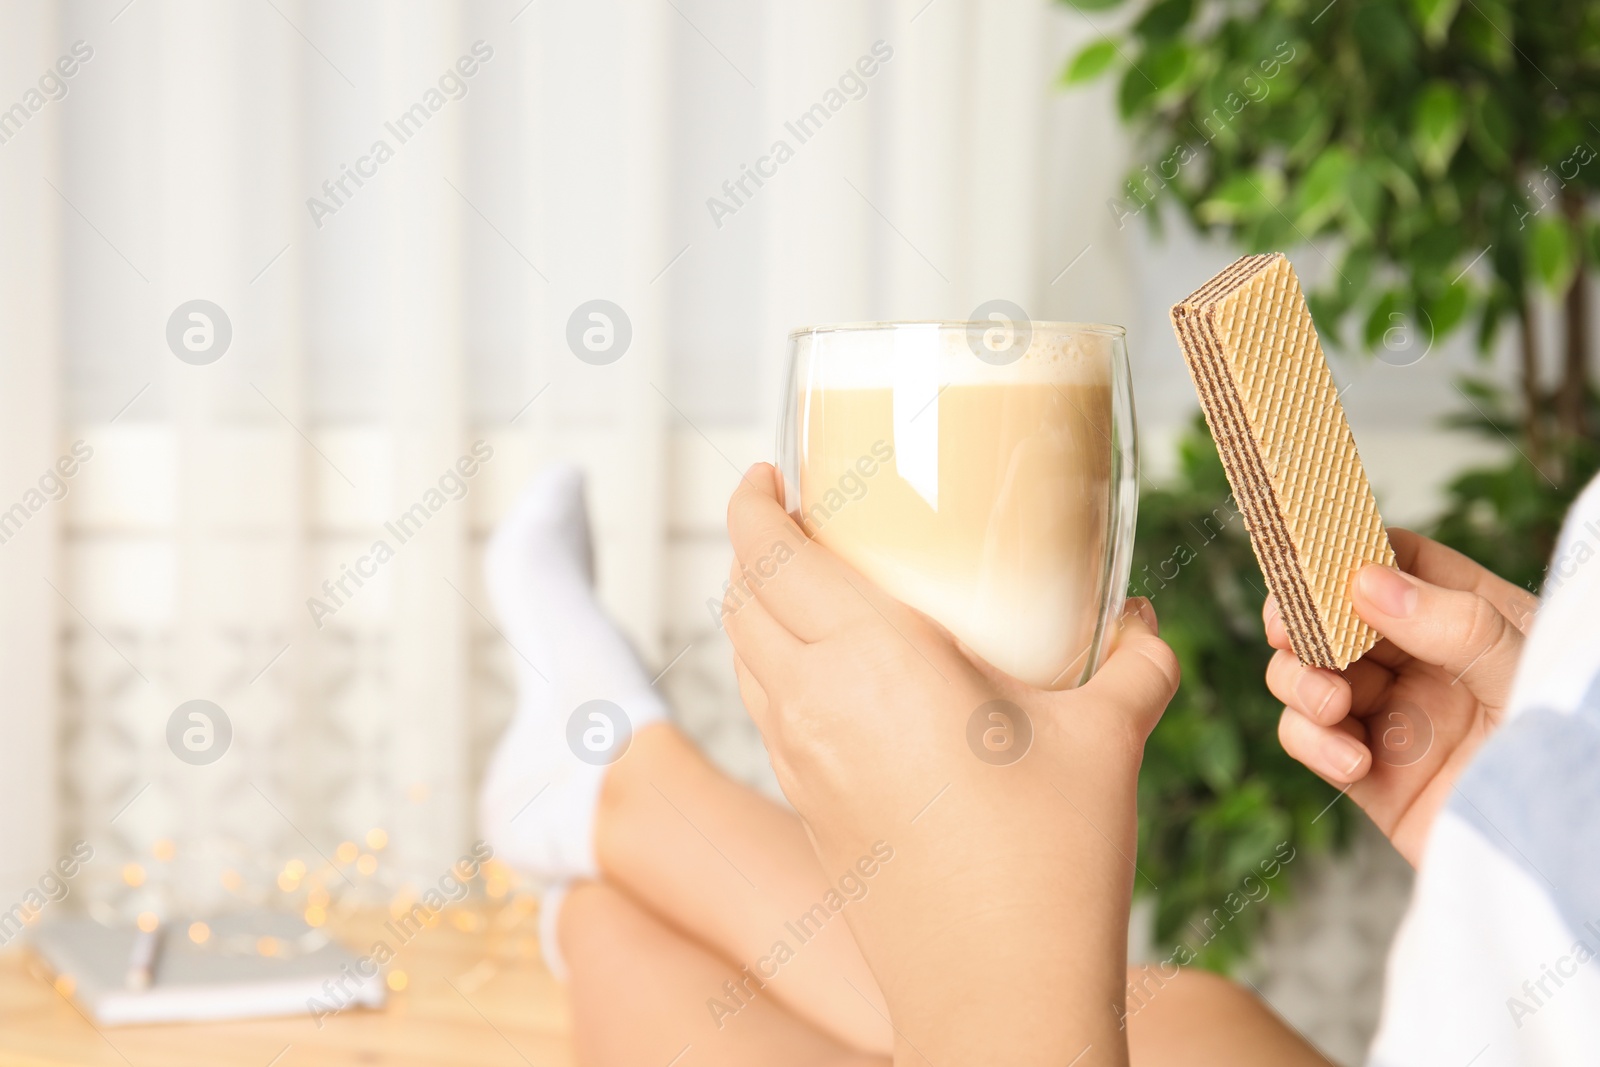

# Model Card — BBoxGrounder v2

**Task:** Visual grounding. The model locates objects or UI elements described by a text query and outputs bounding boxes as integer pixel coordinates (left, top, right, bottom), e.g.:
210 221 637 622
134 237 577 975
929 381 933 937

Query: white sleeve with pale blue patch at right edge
1370 478 1600 1067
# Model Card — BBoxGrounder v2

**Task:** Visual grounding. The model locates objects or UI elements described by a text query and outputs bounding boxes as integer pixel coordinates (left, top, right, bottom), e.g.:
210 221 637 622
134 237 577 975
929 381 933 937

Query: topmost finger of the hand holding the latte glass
728 464 870 643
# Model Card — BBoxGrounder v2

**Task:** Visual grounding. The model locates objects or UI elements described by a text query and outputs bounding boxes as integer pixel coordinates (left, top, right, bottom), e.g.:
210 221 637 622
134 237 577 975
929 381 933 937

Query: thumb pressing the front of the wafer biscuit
1350 563 1523 707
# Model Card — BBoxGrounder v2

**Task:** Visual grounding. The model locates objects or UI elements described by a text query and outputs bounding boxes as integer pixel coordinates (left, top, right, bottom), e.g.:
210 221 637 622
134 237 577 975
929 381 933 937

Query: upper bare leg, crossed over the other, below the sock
595 723 893 1059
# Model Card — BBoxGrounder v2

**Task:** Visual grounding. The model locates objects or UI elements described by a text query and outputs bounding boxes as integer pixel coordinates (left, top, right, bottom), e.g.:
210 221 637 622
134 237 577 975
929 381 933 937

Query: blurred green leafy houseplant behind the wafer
1061 0 1600 966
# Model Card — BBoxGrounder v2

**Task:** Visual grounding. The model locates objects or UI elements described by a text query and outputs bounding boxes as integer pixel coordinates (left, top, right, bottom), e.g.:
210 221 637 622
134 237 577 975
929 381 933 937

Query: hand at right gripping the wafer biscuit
1262 530 1539 865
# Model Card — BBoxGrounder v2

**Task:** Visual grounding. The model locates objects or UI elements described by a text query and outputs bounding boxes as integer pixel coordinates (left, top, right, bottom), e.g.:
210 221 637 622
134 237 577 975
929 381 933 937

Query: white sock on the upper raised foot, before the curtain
478 464 667 885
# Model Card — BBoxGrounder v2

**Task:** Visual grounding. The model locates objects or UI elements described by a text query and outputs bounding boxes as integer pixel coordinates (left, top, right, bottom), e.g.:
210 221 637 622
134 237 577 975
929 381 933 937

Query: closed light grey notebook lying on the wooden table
30 912 386 1025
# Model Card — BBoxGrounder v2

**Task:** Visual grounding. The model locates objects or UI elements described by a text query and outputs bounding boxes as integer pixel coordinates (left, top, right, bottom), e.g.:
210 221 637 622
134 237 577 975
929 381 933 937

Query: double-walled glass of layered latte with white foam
778 318 1138 689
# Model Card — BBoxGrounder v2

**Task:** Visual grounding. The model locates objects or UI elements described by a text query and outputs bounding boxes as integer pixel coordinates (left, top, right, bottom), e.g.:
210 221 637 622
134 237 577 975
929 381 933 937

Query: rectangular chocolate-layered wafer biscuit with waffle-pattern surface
1171 253 1395 669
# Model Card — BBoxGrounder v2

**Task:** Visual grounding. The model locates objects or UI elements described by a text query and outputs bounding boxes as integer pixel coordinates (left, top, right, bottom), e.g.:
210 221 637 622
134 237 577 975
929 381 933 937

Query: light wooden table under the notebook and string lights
0 901 574 1067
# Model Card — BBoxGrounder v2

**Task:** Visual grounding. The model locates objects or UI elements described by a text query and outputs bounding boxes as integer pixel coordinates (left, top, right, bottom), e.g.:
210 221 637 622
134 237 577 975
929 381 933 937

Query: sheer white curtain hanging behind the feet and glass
0 0 1130 907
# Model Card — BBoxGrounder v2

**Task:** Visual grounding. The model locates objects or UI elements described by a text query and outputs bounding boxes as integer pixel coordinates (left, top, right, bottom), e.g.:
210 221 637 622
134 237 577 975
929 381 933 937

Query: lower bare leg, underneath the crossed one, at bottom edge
560 881 888 1067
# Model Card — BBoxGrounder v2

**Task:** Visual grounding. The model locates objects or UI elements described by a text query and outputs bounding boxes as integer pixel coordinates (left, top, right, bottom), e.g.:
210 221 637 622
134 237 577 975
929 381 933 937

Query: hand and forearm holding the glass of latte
723 464 1178 1065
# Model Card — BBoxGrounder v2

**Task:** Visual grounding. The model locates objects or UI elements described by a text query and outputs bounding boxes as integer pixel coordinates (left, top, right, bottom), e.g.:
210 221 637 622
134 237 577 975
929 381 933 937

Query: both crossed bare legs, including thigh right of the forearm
582 725 1326 1067
